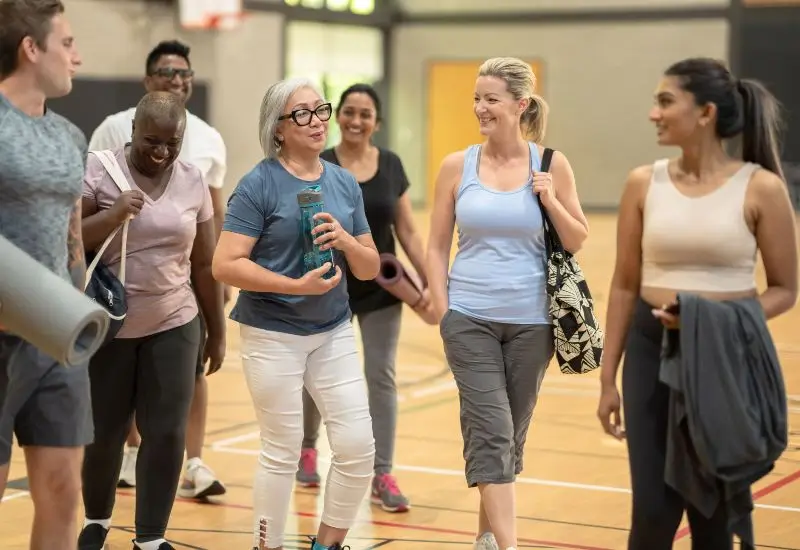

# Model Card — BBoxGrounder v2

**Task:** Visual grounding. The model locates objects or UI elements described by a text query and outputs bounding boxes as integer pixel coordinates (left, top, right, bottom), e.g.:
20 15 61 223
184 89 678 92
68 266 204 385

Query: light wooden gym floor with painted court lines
0 214 800 550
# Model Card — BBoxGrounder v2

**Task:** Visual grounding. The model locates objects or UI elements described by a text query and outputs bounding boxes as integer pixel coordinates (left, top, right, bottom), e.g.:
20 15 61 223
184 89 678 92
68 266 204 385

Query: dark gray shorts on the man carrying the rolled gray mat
0 332 94 465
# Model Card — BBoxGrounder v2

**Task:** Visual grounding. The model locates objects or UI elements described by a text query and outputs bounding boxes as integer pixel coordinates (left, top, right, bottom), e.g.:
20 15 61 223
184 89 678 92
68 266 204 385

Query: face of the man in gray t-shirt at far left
28 14 81 98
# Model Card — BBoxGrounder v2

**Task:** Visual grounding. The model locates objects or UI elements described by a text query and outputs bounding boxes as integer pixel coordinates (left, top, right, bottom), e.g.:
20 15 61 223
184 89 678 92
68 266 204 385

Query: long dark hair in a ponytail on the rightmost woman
664 57 783 179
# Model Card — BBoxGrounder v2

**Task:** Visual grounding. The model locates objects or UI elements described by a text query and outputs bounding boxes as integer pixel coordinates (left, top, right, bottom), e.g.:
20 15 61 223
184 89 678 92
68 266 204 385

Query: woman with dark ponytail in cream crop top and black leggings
597 58 797 550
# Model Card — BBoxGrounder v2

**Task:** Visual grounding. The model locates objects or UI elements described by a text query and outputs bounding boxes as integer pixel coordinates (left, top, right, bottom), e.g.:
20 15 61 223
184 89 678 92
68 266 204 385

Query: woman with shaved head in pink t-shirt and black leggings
79 92 225 550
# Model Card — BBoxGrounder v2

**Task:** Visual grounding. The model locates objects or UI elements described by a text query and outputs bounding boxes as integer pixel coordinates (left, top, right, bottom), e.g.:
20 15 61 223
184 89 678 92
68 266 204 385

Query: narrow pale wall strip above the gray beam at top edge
398 0 730 15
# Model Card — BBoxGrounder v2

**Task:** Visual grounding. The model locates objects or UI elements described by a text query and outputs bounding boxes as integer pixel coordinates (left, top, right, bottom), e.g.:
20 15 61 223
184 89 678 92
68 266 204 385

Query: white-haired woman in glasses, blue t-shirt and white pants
213 79 380 550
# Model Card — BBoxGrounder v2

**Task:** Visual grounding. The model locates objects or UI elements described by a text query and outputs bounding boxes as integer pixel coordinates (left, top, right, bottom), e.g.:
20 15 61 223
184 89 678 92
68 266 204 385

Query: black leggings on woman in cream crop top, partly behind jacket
622 300 744 550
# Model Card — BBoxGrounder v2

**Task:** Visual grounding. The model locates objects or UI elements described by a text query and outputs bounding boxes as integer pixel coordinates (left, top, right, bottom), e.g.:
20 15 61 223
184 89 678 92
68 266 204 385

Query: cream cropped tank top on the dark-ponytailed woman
641 159 759 292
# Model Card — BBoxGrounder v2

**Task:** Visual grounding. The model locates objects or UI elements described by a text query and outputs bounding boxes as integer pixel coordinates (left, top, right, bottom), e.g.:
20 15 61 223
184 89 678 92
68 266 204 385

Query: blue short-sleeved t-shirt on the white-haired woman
222 156 370 335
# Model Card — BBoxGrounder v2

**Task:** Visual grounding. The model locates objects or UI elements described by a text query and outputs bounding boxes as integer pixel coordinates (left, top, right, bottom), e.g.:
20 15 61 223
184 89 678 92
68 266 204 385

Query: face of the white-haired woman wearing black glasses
276 87 331 154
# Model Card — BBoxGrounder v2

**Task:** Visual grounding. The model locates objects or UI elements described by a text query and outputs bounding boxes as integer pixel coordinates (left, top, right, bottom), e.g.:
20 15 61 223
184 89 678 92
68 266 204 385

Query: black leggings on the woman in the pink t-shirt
82 318 201 542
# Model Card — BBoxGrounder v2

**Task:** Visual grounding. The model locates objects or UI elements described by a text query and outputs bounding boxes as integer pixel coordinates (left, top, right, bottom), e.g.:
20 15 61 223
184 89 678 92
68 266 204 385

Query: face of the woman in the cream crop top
650 76 715 146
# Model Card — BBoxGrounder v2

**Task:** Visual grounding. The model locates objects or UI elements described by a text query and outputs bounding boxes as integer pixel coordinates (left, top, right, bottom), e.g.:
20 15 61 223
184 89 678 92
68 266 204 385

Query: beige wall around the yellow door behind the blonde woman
389 19 728 207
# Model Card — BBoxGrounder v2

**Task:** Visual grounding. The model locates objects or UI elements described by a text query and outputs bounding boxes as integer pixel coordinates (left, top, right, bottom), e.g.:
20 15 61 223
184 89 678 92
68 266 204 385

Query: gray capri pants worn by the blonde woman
439 309 553 487
